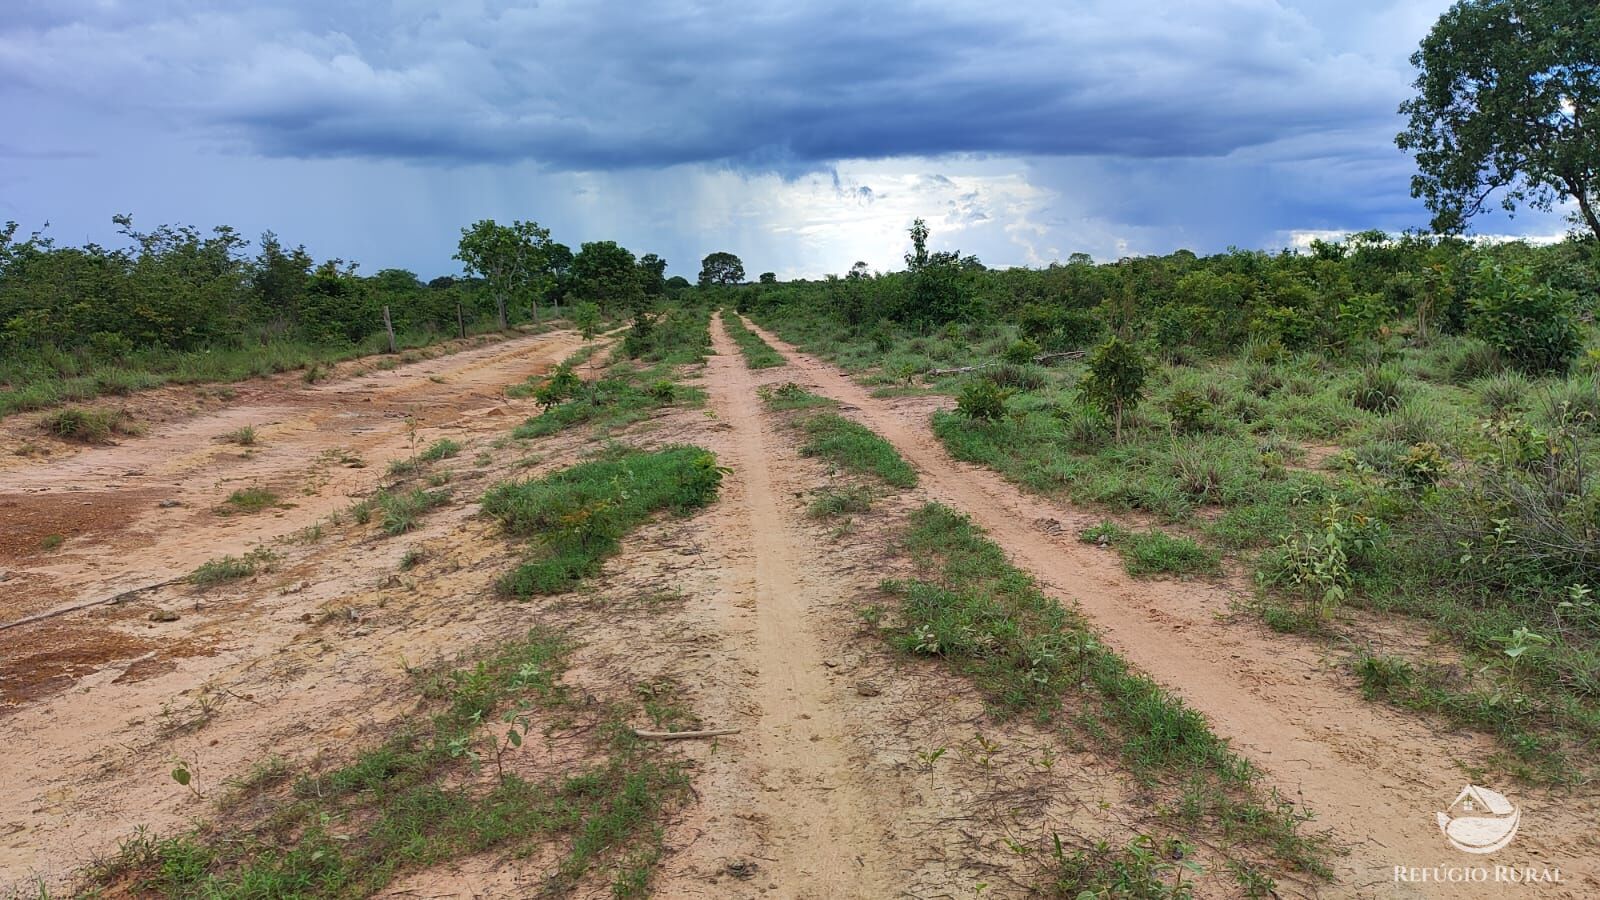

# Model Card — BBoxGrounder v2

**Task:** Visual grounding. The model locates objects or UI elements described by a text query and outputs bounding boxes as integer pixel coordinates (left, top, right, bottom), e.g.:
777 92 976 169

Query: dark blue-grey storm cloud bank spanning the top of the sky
0 0 1403 171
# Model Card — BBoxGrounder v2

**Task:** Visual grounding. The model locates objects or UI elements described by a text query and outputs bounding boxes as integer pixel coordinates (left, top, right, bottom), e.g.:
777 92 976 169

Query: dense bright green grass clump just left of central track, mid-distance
483 447 723 597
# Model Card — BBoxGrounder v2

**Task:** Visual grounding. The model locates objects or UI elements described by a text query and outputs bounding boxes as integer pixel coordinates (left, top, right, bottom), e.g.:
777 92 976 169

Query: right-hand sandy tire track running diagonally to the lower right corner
747 312 1600 897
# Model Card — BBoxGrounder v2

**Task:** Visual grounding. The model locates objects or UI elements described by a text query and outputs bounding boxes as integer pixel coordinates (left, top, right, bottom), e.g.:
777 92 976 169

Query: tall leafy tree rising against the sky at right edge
1395 0 1600 239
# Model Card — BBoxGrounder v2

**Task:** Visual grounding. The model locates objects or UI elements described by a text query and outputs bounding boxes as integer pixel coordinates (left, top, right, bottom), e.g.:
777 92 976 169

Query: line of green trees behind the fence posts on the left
0 215 744 359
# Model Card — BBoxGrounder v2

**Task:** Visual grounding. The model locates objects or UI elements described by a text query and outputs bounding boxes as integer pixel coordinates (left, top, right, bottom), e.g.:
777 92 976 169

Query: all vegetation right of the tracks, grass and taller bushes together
738 219 1600 780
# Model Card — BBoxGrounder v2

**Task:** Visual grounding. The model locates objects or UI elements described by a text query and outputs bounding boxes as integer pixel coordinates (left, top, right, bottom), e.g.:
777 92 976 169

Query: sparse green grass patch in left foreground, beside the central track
93 629 686 898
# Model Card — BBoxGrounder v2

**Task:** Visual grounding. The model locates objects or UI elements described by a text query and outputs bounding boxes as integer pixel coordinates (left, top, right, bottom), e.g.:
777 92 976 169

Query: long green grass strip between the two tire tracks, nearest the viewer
885 503 1326 895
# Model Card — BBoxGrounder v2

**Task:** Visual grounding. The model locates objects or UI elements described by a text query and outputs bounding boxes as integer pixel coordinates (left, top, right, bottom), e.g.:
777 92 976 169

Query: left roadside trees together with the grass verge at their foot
0 216 690 416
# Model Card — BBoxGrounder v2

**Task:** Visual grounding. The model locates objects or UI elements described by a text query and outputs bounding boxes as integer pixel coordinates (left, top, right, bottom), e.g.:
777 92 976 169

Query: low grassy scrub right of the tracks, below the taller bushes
758 293 1600 780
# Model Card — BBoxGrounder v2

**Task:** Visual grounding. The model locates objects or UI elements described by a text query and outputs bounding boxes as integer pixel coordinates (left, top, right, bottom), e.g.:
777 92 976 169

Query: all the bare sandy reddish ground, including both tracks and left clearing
0 312 1600 898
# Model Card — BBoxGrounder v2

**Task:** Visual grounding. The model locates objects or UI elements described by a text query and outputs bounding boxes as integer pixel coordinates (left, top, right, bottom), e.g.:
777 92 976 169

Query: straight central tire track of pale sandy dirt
688 312 894 898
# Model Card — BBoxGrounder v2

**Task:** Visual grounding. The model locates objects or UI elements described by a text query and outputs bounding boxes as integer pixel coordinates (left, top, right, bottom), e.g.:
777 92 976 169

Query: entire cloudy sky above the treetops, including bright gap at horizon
0 0 1563 279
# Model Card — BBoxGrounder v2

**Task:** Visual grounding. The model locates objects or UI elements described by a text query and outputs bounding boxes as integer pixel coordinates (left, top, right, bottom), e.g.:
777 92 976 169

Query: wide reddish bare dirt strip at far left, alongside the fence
0 331 579 620
